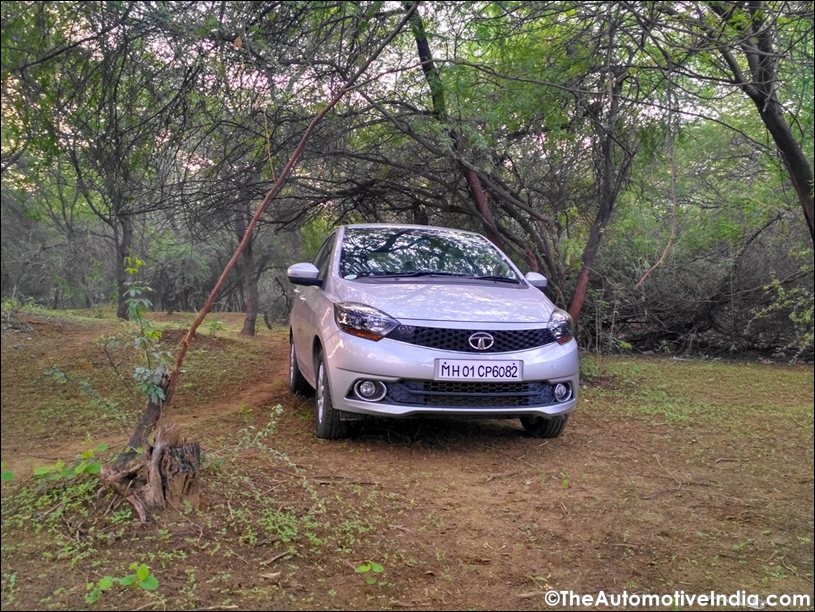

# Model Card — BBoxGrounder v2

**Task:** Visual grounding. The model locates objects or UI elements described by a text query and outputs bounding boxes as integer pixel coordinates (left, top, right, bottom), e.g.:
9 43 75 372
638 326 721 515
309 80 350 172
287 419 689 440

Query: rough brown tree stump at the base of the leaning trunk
101 423 201 523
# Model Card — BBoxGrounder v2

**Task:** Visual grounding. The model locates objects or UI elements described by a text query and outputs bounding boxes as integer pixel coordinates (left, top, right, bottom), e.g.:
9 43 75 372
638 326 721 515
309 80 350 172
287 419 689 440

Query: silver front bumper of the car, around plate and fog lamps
324 331 578 418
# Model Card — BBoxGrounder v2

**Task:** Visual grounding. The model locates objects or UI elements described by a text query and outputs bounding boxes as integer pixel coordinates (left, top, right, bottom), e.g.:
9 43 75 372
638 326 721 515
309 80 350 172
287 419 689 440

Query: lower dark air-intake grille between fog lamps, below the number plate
383 380 555 408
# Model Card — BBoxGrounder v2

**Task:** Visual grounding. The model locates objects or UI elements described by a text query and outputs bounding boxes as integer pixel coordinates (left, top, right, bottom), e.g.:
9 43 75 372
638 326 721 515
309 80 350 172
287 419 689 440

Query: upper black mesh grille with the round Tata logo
387 325 555 353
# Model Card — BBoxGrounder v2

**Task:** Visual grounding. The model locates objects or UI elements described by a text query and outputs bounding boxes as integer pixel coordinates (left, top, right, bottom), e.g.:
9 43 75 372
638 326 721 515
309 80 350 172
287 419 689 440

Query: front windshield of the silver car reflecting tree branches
340 227 520 283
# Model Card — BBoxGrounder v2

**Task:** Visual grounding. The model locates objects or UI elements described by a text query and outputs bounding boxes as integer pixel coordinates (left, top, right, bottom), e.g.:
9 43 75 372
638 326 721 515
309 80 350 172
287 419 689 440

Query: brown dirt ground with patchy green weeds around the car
0 315 813 610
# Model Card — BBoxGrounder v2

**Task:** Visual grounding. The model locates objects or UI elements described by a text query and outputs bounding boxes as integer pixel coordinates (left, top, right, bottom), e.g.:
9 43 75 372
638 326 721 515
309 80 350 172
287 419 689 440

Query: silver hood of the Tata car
335 279 554 323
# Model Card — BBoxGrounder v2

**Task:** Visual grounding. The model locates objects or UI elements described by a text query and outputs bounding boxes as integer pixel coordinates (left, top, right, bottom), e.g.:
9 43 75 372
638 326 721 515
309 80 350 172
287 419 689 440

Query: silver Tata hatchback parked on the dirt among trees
288 224 578 439
